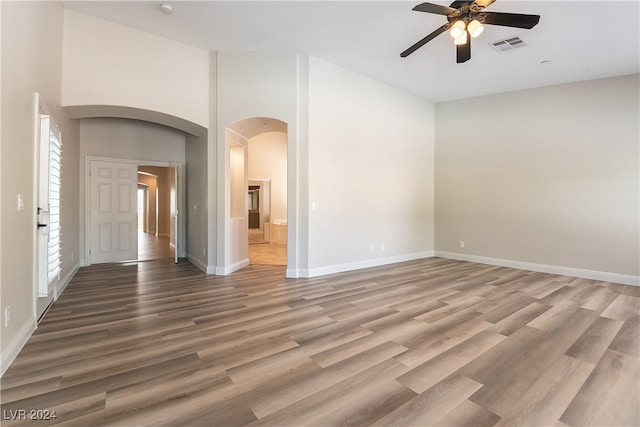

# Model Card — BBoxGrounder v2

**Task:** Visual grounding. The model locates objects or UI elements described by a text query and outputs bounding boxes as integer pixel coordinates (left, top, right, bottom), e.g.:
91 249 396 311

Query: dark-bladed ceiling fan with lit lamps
400 0 540 64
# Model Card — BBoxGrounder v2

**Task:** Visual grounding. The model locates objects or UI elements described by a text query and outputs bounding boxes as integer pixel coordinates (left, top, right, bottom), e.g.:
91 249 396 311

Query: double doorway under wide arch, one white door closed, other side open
85 157 185 265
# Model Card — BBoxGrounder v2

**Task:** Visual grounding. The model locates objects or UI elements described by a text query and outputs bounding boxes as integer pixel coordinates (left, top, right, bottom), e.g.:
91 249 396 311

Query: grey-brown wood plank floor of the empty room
1 258 640 427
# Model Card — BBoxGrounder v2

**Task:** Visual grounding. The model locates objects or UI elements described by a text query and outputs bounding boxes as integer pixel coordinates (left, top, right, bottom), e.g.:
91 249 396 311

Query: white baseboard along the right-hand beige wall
435 251 640 286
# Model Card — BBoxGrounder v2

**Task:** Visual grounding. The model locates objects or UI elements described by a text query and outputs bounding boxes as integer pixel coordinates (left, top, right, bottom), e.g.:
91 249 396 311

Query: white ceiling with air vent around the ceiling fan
63 0 640 102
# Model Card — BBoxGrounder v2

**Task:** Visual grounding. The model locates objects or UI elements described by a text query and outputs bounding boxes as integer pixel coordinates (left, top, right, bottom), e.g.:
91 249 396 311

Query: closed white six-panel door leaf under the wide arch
89 160 138 264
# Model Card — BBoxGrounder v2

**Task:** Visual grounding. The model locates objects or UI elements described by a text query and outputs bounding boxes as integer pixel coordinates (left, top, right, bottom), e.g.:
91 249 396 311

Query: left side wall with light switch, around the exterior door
0 2 79 372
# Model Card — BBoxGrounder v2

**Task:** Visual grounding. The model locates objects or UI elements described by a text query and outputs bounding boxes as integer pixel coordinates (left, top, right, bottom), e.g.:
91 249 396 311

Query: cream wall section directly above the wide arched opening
62 9 209 128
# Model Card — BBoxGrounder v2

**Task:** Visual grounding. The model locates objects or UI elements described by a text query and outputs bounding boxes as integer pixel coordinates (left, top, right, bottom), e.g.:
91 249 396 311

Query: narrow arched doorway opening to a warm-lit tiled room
225 117 288 270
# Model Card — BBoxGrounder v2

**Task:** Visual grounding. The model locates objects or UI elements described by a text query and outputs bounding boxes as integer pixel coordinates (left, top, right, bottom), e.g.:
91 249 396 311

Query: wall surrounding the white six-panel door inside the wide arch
78 118 186 259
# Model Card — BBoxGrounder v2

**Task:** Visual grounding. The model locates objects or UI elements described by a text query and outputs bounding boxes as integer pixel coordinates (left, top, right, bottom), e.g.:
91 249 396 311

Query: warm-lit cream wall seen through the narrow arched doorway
249 132 287 224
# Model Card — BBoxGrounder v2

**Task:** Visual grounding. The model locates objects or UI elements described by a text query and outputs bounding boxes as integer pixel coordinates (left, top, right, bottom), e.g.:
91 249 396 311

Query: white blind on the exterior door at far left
47 122 62 284
